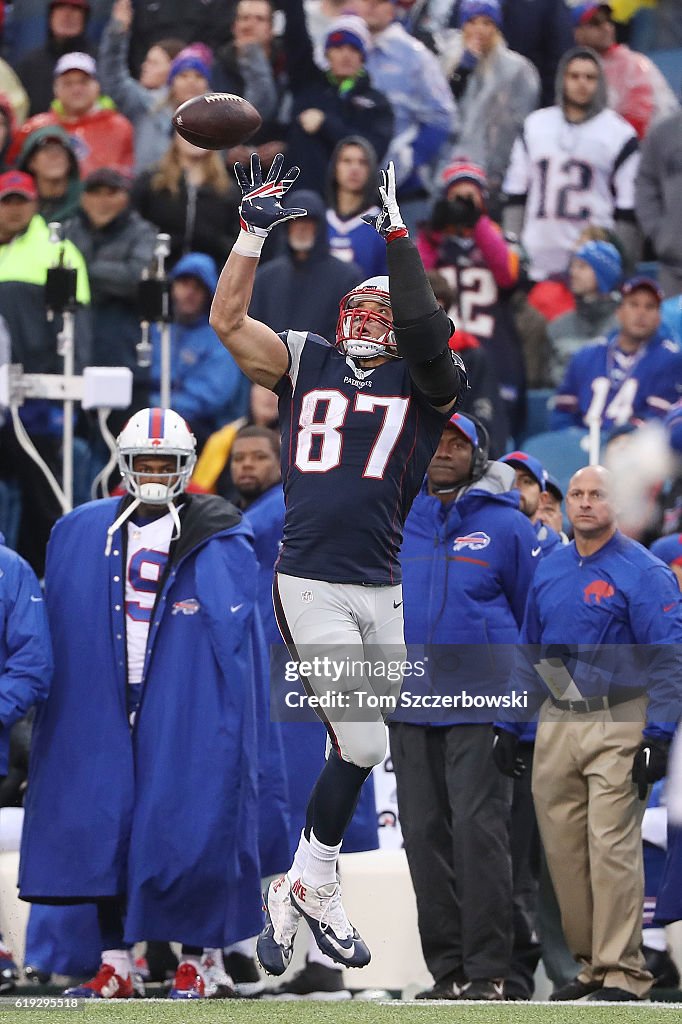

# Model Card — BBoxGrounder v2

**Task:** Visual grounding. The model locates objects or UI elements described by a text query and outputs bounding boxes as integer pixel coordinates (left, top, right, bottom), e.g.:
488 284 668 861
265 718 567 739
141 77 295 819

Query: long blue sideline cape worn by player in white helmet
19 495 264 946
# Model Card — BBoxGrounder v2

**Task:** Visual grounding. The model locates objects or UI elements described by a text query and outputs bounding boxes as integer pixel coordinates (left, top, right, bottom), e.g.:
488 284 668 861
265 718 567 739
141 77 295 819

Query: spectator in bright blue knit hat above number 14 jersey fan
547 242 623 385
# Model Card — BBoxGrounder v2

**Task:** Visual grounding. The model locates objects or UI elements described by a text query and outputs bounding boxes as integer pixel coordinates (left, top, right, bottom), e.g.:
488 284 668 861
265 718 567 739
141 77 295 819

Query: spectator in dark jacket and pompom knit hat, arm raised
284 0 393 195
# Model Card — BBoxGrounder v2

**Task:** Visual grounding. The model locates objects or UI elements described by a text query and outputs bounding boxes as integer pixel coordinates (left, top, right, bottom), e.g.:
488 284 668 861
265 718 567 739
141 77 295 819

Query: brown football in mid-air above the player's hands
172 92 262 150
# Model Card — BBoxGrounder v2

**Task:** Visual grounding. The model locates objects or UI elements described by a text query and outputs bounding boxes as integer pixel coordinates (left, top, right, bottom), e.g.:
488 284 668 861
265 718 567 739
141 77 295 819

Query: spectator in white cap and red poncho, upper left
12 52 133 177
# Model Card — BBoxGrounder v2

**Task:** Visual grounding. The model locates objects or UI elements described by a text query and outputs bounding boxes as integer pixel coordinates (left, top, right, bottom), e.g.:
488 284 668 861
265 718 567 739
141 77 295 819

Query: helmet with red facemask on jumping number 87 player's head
336 276 399 359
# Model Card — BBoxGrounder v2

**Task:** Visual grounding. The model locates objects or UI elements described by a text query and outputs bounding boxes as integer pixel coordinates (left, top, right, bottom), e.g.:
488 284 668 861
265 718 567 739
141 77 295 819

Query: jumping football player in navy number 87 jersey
211 154 467 975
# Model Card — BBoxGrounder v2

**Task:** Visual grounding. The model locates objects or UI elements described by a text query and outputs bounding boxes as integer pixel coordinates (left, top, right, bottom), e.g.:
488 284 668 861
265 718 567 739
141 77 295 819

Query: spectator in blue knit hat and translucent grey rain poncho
438 0 540 215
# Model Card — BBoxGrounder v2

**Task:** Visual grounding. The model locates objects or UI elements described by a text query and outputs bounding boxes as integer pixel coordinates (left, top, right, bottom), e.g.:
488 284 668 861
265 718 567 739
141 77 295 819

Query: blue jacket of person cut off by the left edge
0 548 52 775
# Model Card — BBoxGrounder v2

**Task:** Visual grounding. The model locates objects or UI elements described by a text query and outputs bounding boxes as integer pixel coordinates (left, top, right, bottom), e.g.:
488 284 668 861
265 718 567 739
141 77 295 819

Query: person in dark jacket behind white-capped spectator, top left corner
16 0 92 116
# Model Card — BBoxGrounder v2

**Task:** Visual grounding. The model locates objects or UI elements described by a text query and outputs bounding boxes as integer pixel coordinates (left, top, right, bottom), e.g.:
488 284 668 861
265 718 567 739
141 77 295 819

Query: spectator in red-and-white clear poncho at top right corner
571 0 679 138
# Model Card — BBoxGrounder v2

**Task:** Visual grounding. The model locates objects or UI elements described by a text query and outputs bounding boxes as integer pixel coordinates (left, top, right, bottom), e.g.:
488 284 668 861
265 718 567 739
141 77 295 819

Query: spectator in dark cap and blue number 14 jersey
550 276 682 430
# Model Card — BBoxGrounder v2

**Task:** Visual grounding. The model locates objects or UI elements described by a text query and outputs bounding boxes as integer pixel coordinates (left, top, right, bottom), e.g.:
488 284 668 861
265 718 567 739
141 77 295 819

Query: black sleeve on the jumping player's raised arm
387 238 468 407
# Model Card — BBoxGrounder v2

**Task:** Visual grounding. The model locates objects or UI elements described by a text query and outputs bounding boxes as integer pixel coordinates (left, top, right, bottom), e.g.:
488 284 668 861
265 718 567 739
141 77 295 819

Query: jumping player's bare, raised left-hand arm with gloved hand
210 153 306 388
